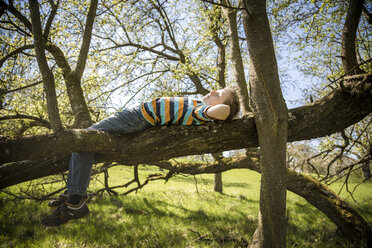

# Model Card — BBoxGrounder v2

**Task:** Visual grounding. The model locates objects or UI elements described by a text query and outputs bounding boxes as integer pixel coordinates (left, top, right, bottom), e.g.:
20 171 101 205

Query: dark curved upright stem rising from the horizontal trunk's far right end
341 0 364 75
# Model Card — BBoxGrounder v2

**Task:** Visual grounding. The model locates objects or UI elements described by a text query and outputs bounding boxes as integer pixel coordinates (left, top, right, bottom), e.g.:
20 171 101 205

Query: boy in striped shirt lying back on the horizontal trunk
42 86 240 226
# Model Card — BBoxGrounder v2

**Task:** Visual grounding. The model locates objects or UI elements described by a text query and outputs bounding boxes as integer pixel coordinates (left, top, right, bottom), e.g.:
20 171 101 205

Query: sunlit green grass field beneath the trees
0 166 372 248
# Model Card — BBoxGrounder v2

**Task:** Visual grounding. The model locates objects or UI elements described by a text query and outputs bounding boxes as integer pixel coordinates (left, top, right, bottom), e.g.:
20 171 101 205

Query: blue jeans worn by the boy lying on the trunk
67 106 151 195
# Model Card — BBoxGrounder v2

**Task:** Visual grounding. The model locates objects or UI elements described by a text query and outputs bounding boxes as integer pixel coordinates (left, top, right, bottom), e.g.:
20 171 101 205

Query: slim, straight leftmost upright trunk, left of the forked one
29 0 62 132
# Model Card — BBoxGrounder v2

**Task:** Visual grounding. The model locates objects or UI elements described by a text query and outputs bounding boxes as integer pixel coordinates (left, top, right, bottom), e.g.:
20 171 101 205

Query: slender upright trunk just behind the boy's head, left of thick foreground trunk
222 0 251 115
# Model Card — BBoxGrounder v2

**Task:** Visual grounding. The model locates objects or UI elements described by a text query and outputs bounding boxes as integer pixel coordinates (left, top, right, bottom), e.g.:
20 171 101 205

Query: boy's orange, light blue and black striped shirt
141 97 213 126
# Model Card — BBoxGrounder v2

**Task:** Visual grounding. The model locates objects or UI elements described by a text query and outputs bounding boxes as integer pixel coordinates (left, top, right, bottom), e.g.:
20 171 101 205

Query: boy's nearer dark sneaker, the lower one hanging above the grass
41 200 89 226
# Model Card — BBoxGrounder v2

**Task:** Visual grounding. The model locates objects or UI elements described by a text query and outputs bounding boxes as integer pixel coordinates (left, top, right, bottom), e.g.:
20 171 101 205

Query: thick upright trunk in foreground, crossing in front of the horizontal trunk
243 0 288 248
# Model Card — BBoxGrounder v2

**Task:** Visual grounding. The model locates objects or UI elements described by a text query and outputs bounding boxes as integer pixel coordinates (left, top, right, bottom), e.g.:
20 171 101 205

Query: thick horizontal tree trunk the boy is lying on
0 75 372 187
